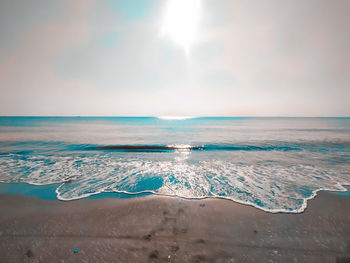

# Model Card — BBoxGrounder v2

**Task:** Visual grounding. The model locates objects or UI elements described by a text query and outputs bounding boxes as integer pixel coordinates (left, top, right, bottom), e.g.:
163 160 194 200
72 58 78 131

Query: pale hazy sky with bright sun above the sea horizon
0 0 350 116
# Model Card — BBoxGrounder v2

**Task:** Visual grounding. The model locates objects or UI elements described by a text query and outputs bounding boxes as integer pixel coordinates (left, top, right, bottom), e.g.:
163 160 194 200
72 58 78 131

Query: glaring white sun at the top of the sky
162 0 200 53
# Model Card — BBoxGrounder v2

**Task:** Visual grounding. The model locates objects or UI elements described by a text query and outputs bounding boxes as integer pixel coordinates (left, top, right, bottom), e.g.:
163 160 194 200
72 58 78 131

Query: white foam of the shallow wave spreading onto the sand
0 152 350 213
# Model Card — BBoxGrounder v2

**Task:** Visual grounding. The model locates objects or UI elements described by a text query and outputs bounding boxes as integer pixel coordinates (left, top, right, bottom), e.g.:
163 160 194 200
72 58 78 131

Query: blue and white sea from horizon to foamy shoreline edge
0 117 350 213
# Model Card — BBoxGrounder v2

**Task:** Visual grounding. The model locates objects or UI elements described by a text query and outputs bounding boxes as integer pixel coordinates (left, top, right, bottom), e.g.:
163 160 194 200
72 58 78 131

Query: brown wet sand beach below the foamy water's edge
0 192 350 263
